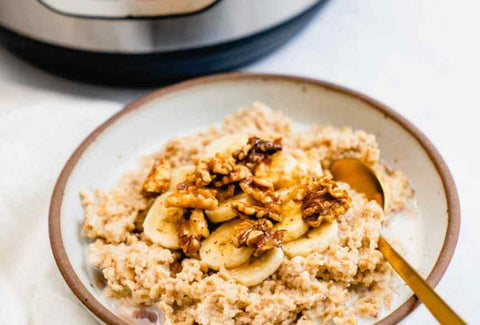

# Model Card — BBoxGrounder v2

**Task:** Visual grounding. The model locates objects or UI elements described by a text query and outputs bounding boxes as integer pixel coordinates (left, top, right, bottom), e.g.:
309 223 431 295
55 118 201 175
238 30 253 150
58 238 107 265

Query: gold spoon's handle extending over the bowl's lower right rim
378 236 466 325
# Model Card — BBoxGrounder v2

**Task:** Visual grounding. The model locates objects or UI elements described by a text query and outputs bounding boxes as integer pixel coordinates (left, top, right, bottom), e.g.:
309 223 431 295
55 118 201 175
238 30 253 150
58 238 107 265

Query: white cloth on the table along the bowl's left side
0 83 122 325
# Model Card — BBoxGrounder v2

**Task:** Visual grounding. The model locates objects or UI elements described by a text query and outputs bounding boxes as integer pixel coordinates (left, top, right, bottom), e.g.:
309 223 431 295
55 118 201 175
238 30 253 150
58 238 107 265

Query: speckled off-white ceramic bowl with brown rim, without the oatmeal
49 74 460 324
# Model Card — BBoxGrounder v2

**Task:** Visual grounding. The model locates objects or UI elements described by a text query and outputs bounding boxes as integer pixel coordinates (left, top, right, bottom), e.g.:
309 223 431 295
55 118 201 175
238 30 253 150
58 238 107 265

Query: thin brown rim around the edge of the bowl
48 73 460 325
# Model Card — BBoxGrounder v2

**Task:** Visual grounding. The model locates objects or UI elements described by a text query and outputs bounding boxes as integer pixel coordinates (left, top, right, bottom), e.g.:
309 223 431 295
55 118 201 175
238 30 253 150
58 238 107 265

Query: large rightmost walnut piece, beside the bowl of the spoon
302 177 352 227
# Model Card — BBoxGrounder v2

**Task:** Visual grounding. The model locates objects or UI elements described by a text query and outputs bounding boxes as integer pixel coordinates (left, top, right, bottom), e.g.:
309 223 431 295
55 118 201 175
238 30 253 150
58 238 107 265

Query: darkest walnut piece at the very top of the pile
233 137 282 168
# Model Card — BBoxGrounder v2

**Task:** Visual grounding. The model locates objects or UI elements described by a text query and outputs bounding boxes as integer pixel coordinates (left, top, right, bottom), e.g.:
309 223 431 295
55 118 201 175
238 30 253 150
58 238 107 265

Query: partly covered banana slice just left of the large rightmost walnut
275 200 309 243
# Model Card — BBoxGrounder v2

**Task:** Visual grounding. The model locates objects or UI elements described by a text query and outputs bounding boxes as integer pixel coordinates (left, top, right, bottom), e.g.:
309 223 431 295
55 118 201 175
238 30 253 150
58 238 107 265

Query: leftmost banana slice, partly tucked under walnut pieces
143 192 183 249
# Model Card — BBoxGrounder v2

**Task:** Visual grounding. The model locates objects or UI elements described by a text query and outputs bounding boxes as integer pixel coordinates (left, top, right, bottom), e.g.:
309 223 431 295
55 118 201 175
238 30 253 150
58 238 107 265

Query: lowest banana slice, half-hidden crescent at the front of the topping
230 247 283 287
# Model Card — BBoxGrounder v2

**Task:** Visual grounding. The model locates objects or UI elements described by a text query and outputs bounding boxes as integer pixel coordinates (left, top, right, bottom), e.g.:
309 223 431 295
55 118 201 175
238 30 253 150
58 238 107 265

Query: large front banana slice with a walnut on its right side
199 219 253 270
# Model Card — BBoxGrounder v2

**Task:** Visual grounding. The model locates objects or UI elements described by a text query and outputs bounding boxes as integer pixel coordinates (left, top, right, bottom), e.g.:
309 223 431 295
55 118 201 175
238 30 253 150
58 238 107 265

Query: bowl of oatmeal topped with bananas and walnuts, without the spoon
49 74 460 324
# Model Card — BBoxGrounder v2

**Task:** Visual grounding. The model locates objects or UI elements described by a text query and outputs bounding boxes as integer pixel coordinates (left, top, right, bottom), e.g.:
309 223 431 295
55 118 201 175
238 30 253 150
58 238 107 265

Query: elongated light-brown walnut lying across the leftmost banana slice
165 186 218 210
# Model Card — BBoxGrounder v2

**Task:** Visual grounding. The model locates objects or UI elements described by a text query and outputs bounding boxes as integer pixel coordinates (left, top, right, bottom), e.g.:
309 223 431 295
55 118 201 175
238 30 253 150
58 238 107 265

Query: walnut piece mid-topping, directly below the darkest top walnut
240 176 282 210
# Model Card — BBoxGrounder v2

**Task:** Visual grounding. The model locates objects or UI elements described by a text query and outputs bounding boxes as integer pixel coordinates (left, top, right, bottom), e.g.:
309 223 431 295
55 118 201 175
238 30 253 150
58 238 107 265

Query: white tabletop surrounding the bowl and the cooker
0 0 480 324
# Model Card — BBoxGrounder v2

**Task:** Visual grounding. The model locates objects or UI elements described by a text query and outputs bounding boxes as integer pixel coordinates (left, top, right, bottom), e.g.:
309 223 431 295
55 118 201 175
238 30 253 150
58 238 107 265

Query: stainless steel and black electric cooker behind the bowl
0 0 325 86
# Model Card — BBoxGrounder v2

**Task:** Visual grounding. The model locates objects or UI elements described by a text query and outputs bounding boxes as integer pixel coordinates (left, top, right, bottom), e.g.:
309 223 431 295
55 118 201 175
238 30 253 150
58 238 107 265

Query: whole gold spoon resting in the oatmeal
330 159 466 325
